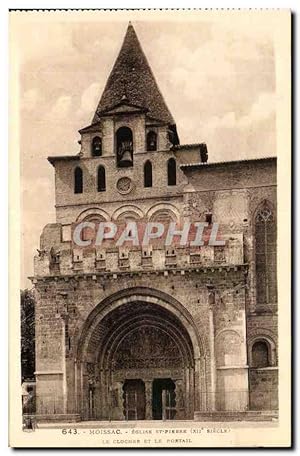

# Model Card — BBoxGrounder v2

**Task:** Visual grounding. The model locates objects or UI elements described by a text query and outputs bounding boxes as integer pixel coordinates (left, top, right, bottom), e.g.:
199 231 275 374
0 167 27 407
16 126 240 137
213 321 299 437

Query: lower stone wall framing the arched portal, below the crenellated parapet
36 269 247 413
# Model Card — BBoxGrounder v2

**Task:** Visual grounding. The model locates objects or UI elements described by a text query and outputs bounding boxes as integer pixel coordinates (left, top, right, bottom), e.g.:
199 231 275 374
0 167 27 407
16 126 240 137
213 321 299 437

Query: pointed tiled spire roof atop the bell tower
93 22 175 125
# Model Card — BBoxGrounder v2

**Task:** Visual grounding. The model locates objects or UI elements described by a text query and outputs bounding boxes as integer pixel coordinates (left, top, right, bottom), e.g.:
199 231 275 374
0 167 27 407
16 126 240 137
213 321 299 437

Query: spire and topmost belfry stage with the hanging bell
80 23 179 168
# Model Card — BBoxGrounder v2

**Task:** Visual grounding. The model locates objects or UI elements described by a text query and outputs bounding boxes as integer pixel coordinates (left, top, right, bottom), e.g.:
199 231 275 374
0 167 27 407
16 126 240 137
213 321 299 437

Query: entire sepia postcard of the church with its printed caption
10 10 291 448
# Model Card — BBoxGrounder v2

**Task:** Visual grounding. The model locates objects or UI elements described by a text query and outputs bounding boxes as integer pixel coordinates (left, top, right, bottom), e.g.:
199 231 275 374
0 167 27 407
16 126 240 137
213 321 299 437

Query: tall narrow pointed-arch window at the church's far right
255 203 277 304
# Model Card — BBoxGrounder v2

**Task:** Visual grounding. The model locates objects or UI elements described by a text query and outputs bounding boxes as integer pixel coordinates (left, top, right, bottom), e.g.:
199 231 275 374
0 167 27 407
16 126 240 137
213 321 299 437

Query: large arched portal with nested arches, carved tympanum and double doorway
77 294 204 420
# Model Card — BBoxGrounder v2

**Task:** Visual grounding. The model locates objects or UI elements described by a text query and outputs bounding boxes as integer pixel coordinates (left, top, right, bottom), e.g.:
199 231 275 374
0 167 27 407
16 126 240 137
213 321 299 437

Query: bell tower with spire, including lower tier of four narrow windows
48 23 205 230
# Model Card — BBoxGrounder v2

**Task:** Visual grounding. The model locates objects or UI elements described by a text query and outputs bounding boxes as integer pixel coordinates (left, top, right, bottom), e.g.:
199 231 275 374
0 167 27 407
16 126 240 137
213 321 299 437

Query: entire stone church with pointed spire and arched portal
31 24 278 422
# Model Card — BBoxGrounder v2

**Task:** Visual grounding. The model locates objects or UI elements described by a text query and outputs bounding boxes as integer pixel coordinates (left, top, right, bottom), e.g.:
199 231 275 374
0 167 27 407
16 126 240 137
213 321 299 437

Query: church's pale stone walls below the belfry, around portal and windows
34 146 277 418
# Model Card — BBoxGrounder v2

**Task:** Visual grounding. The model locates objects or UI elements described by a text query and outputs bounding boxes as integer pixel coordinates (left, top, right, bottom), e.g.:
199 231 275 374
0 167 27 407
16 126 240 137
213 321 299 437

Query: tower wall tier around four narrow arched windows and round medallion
55 151 186 222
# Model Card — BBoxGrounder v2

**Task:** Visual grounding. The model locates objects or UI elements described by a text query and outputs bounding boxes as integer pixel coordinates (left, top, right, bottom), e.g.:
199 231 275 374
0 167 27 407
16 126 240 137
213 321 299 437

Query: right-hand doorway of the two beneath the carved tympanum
152 378 176 420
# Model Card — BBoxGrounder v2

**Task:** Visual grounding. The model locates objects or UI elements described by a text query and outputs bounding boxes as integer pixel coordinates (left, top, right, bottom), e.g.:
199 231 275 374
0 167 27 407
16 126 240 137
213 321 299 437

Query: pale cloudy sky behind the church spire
13 15 276 287
